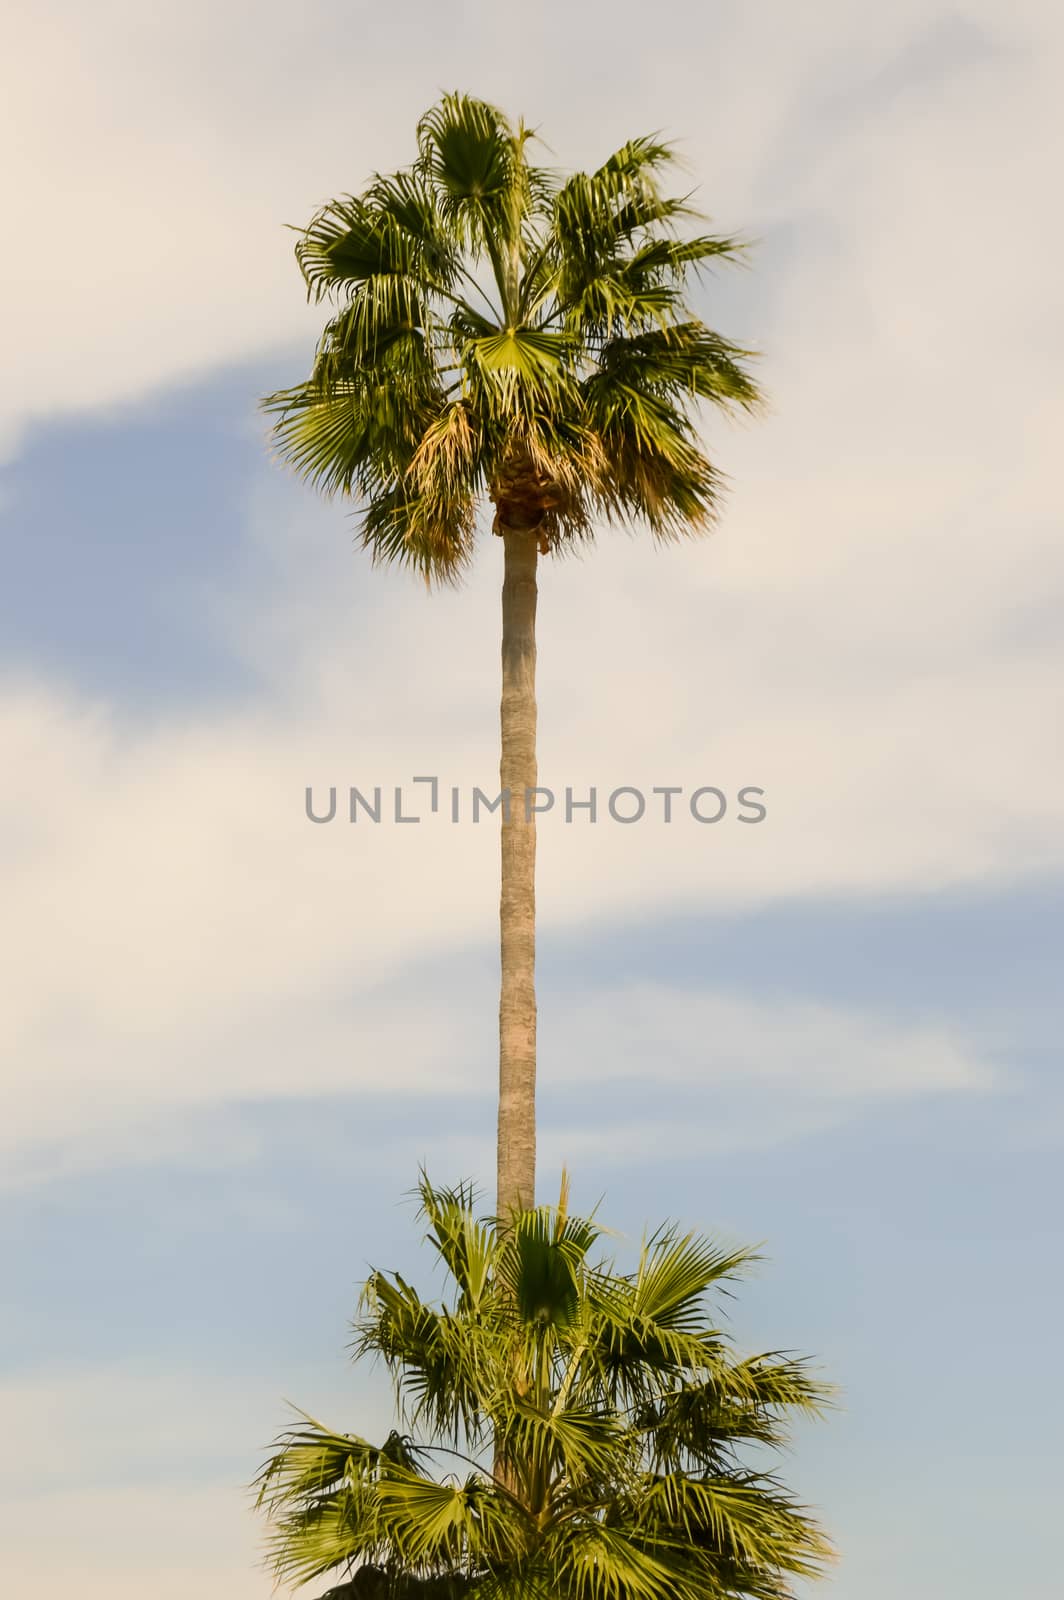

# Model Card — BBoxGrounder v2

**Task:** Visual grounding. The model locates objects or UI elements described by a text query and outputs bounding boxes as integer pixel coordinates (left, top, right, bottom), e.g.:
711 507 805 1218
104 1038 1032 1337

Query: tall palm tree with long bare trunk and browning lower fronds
266 94 757 1219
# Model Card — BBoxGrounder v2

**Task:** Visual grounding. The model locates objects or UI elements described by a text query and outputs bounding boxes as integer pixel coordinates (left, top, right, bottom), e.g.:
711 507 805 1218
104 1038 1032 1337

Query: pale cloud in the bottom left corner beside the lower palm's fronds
0 1352 392 1600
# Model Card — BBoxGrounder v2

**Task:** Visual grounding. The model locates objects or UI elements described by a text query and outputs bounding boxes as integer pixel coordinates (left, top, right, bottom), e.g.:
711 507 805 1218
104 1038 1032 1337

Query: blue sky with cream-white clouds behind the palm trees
0 0 1064 1600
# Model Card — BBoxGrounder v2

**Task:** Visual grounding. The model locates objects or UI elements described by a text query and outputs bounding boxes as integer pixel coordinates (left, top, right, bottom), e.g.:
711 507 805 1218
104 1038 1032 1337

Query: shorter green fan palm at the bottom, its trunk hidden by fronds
258 1179 830 1600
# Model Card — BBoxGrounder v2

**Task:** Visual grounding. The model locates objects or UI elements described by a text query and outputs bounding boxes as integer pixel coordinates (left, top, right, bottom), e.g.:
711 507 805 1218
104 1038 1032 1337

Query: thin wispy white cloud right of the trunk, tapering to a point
541 984 1003 1171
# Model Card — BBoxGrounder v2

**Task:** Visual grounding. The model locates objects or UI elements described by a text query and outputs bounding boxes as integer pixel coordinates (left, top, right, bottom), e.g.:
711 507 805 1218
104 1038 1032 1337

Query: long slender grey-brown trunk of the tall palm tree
498 528 539 1219
